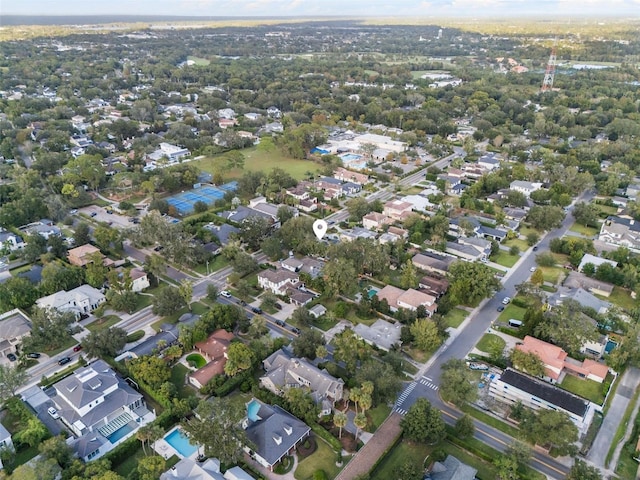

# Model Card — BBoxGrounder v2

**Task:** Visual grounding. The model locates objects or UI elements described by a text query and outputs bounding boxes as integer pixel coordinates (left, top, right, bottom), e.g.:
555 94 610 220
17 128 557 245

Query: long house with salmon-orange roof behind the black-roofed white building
516 335 609 383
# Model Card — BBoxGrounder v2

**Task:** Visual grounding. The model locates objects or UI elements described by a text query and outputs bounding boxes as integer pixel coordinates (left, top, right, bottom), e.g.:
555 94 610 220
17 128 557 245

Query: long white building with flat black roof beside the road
489 368 594 432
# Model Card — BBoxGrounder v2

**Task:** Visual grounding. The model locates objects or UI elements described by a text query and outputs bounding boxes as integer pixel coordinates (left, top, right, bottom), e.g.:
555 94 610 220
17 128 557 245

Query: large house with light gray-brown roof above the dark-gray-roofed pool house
260 349 344 416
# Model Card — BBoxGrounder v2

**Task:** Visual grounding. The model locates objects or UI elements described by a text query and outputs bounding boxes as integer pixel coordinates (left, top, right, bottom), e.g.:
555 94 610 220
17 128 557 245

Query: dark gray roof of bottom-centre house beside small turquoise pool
246 400 311 465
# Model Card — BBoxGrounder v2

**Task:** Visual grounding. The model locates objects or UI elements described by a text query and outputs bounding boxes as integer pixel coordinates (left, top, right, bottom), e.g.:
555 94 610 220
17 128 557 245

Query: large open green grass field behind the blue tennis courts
194 147 320 181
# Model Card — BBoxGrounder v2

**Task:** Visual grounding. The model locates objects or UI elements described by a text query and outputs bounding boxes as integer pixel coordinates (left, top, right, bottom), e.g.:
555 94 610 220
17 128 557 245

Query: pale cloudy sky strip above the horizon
0 0 640 17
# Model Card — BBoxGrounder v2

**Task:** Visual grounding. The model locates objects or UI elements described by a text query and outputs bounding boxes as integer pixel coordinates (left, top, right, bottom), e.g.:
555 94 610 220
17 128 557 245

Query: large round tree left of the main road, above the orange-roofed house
449 261 500 305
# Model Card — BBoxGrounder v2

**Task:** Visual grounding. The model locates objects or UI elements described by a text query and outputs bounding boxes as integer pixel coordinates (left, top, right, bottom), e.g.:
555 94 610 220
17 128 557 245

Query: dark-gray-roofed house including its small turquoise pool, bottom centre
242 398 311 471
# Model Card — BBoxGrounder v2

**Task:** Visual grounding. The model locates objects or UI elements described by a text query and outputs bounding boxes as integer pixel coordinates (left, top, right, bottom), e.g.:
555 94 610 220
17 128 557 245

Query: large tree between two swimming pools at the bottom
182 397 249 465
